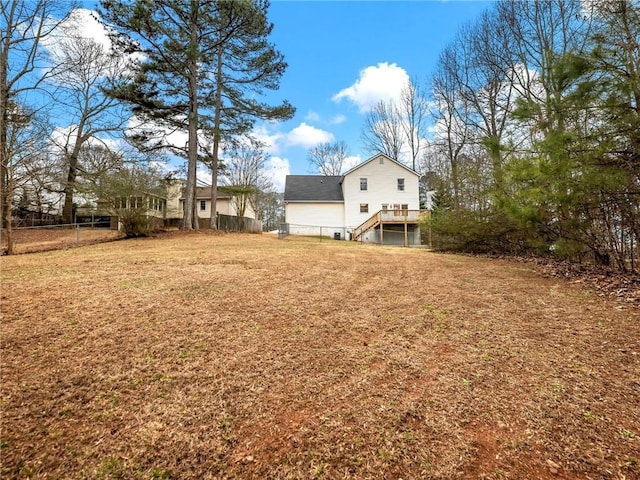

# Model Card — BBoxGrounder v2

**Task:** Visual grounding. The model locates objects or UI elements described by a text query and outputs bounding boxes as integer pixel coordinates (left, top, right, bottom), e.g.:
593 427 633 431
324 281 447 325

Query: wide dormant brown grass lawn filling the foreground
0 234 640 480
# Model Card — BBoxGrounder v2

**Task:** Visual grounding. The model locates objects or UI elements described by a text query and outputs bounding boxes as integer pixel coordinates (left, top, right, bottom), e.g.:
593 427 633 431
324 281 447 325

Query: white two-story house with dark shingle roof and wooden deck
284 153 420 245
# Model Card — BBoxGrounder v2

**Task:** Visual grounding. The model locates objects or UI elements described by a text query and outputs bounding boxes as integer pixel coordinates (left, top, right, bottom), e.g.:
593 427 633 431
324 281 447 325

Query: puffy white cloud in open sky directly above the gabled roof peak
332 62 409 113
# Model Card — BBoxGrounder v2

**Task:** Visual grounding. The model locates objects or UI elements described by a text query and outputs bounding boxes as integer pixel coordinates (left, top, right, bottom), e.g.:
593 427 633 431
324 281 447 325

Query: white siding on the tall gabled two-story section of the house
342 156 420 228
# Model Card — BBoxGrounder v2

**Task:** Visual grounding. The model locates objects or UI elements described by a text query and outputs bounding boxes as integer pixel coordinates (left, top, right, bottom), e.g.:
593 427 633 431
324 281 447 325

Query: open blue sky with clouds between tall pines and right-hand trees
254 0 491 185
